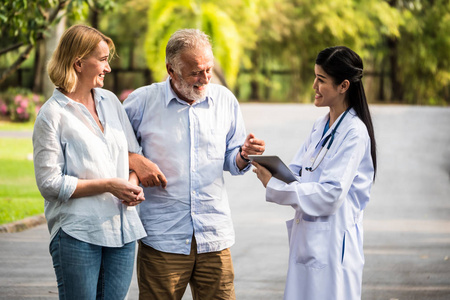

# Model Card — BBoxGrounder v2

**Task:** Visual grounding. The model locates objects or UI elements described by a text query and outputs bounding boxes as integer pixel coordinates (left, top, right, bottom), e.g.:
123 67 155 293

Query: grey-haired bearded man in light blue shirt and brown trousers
124 29 265 300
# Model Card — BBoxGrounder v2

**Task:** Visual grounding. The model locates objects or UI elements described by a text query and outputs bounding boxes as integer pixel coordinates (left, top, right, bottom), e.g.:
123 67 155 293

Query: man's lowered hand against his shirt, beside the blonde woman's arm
128 153 167 188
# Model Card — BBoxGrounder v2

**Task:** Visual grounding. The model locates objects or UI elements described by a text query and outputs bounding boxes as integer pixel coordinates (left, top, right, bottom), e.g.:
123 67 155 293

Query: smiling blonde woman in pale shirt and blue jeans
33 25 146 299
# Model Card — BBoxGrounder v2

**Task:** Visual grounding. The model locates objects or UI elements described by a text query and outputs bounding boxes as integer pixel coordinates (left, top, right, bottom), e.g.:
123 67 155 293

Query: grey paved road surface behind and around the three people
0 104 450 300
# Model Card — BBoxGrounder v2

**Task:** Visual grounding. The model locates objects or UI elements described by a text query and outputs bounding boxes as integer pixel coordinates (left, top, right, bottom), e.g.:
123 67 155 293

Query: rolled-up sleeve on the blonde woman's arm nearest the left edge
33 115 78 202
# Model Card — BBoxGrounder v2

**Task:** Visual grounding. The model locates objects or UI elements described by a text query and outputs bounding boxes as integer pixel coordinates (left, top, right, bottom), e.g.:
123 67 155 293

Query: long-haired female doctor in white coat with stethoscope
253 46 376 300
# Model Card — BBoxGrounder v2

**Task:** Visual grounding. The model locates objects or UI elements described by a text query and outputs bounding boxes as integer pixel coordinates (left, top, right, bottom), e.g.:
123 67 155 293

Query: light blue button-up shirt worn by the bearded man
124 78 250 254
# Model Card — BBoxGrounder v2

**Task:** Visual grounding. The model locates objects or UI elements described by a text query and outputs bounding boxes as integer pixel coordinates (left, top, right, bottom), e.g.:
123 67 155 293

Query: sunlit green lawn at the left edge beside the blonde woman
0 137 44 224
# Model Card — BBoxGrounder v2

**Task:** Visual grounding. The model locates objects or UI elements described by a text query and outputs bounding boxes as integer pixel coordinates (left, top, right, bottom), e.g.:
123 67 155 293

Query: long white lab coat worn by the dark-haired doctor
266 109 374 300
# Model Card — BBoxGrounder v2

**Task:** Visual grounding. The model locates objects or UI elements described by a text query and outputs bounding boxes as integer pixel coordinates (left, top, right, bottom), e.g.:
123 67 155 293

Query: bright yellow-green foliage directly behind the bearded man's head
145 0 257 87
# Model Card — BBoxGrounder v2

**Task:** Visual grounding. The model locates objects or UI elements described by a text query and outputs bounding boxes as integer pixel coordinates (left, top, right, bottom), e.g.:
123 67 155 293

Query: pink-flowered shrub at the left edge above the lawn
0 88 44 122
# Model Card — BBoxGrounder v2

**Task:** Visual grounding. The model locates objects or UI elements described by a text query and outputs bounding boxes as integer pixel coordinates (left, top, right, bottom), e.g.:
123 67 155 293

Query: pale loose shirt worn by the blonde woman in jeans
33 89 145 247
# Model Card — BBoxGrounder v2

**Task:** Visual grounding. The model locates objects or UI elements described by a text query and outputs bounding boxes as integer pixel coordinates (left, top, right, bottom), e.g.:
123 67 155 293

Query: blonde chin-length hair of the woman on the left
47 25 115 93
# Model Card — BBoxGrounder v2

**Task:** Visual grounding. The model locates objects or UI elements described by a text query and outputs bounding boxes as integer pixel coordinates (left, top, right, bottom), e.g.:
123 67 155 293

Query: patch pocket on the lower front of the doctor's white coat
296 219 331 269
